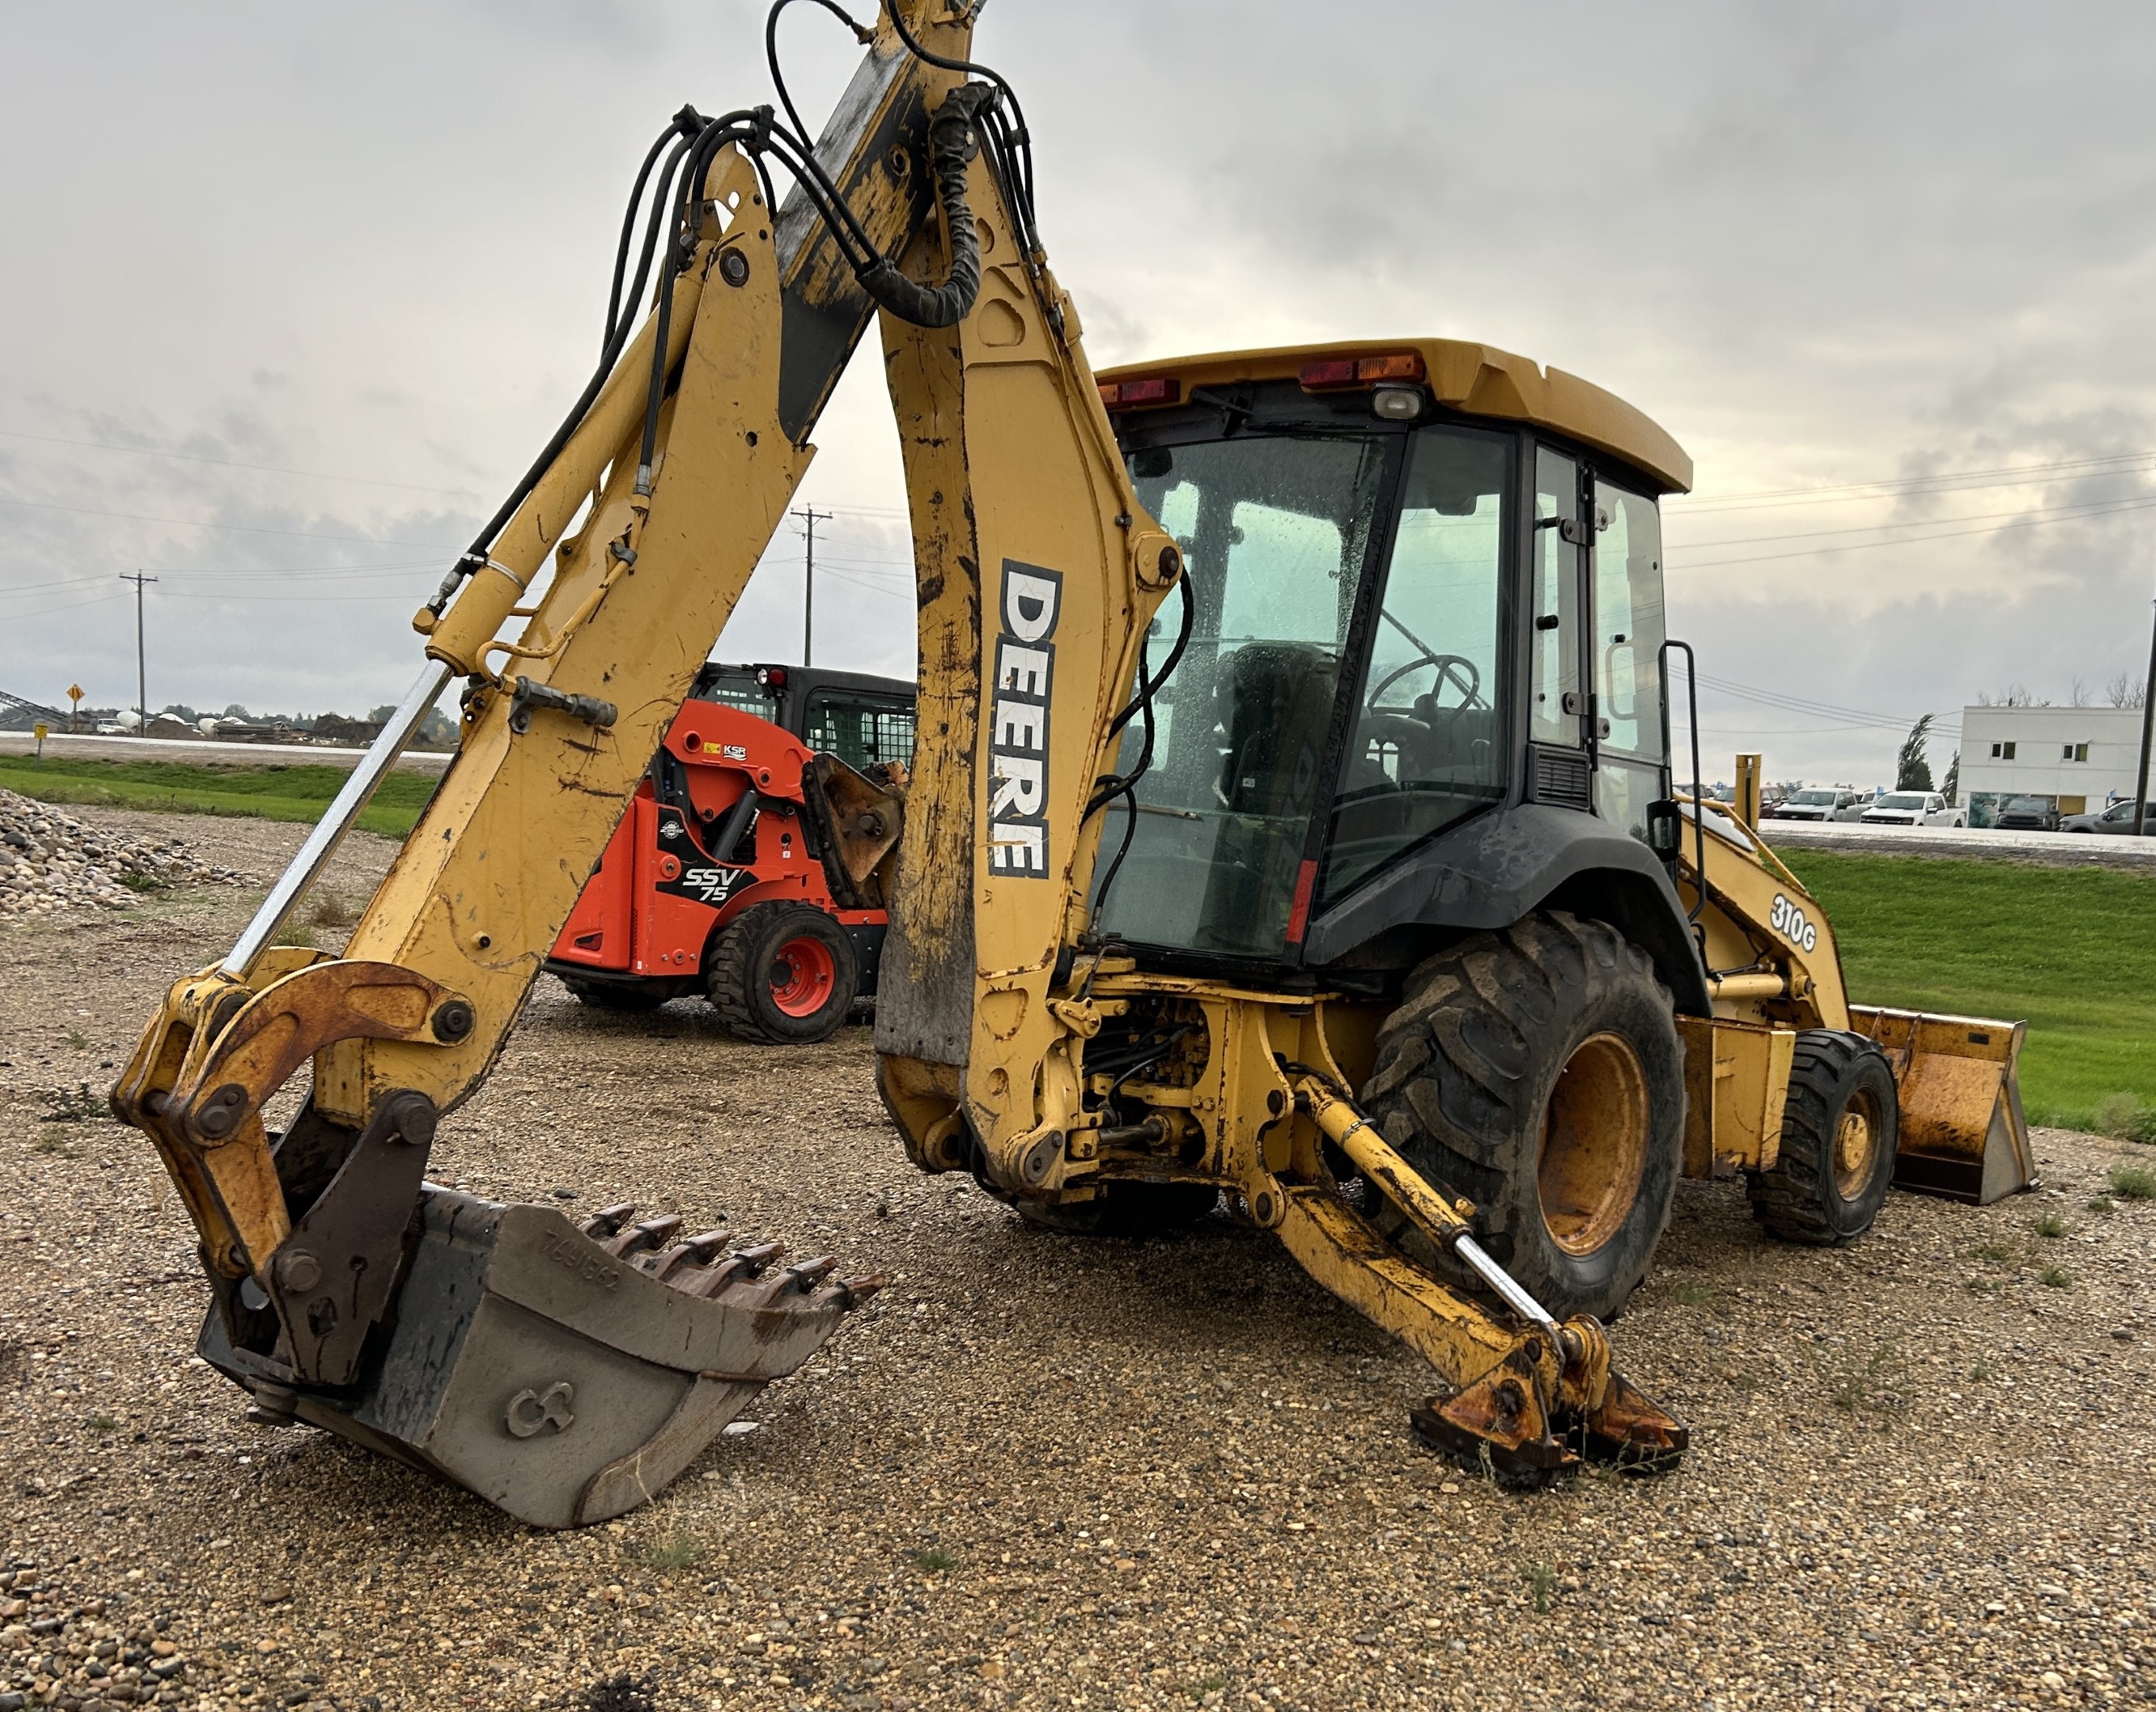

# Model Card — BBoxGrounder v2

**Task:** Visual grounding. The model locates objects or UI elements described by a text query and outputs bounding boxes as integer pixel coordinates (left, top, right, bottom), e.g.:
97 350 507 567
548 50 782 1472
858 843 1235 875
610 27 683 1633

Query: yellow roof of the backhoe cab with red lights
1095 338 1692 494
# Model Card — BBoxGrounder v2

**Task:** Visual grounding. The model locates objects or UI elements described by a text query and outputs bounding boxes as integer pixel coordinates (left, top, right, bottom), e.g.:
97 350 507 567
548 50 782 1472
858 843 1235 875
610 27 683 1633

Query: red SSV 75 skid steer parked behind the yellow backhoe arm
545 664 914 1045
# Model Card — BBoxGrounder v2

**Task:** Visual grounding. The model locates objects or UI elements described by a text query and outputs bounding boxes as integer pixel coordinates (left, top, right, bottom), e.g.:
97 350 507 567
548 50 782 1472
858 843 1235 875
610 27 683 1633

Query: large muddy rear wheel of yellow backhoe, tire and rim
1363 910 1684 1320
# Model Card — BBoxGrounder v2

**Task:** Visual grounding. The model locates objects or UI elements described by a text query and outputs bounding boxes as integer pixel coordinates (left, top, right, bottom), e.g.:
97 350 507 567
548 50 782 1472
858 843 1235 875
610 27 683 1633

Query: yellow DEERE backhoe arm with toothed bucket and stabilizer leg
112 0 1684 1527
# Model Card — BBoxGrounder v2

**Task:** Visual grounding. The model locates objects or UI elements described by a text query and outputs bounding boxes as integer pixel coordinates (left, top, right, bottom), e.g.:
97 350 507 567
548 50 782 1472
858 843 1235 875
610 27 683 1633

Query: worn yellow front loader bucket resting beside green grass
1850 1005 2037 1207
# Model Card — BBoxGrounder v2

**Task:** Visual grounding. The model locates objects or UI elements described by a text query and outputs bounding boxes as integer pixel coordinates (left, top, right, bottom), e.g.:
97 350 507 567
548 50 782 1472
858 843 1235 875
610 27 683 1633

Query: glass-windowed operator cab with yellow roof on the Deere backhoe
1097 341 1690 968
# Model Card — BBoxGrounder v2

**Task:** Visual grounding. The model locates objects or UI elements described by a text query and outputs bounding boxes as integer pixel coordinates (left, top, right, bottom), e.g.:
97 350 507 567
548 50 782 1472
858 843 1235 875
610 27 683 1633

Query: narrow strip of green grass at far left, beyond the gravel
0 755 435 839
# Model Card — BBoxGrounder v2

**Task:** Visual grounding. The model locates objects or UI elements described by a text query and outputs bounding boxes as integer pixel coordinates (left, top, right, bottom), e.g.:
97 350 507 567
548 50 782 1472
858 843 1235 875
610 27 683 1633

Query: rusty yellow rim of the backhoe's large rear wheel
1535 1035 1647 1255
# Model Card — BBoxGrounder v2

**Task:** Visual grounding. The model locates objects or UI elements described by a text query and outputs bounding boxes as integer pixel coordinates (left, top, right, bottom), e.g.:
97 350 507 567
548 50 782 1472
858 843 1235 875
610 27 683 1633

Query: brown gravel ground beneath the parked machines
0 813 2156 1712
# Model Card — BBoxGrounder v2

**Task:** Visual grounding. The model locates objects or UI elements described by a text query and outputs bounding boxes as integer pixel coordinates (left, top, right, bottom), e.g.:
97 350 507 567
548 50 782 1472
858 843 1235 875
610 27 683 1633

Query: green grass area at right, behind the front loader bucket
1779 850 2156 1129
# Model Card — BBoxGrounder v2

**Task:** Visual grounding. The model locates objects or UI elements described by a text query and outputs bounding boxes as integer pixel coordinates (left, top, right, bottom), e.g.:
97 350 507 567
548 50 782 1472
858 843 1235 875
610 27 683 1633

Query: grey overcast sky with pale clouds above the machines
0 0 2156 783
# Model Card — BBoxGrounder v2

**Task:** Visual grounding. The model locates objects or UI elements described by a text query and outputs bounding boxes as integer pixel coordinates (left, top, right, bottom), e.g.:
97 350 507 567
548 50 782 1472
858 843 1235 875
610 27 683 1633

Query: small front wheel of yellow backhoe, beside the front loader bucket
1749 1029 1902 1248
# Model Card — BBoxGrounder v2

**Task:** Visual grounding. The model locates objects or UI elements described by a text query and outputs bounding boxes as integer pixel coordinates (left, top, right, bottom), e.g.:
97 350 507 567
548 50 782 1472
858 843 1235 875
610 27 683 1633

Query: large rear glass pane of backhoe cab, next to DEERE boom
1095 436 1388 955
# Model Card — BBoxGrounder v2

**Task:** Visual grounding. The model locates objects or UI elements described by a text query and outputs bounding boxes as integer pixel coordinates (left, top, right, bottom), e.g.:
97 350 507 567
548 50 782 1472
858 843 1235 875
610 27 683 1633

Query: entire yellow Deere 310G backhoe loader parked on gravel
112 0 2029 1527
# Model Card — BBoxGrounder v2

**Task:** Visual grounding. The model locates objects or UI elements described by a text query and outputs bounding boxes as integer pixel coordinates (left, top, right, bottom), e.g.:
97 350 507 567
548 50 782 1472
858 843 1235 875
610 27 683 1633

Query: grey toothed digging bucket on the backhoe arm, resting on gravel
201 1186 881 1529
